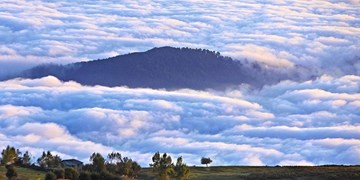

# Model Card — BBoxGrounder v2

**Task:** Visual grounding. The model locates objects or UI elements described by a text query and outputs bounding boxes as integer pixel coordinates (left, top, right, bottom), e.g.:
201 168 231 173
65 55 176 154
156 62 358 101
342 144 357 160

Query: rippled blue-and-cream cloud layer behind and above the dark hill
0 0 360 75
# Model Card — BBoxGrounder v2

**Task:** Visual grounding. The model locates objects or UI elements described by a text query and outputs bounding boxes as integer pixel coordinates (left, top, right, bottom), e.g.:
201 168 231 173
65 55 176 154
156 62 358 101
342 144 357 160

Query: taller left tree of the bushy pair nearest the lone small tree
150 152 174 180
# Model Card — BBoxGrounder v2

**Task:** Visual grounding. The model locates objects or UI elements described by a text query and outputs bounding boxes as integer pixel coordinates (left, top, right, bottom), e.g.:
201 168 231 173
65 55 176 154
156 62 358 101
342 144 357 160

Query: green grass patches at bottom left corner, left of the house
0 166 45 180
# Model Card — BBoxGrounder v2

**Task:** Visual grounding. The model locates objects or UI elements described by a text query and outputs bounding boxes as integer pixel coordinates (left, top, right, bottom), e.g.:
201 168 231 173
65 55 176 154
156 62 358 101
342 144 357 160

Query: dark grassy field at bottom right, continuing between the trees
139 166 360 180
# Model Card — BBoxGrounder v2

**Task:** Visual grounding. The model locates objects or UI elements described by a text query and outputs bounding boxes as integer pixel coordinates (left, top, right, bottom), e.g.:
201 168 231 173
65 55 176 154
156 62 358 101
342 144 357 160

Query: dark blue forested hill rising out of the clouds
3 47 312 89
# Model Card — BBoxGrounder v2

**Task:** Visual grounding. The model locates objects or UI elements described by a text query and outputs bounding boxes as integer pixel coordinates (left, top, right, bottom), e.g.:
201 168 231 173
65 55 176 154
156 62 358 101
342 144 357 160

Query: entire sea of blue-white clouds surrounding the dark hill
0 0 360 166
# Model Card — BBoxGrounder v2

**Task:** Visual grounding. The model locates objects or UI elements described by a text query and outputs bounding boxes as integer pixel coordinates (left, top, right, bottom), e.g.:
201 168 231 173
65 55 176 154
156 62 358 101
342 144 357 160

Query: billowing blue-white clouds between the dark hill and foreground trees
0 75 360 166
